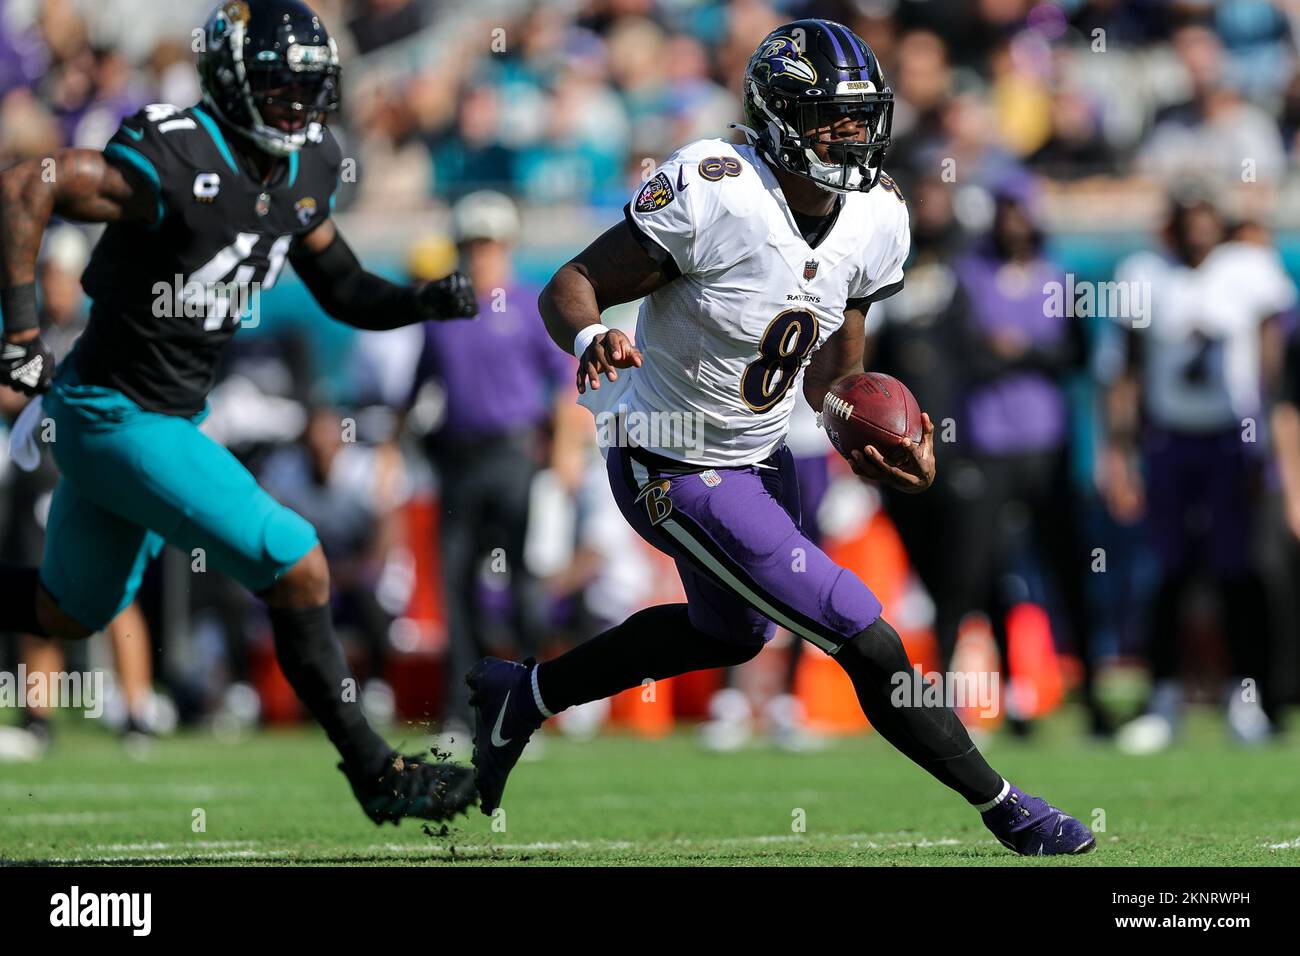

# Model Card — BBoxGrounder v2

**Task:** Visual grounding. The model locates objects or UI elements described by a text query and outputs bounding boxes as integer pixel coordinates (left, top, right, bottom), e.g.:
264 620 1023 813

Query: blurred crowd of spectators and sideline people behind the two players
0 0 1300 750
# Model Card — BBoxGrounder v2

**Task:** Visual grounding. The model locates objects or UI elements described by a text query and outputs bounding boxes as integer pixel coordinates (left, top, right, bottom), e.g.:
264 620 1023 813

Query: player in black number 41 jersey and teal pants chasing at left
0 0 478 823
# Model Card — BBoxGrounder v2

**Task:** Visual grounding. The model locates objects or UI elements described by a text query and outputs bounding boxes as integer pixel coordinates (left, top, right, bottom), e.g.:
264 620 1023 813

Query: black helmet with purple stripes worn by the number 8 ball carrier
742 20 893 193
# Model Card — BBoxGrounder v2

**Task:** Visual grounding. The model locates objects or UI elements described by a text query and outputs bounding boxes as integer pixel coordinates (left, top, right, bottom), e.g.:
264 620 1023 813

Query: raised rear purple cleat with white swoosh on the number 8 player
465 657 542 817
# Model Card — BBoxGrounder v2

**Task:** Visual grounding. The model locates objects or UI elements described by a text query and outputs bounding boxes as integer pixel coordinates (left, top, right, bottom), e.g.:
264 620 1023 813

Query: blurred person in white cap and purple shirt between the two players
412 190 572 736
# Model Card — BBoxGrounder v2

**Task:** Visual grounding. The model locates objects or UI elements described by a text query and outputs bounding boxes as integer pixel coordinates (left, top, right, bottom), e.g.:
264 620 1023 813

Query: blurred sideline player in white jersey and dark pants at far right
1102 187 1296 753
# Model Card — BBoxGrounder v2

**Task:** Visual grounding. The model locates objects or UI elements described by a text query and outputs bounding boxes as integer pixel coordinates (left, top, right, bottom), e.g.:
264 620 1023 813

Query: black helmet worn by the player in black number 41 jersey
199 0 341 156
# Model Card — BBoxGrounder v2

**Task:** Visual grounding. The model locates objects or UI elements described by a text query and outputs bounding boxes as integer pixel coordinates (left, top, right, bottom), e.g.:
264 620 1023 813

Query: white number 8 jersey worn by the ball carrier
580 139 911 467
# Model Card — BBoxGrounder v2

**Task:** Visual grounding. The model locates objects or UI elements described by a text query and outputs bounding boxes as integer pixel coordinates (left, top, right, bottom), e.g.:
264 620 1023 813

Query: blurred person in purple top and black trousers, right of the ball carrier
936 176 1110 736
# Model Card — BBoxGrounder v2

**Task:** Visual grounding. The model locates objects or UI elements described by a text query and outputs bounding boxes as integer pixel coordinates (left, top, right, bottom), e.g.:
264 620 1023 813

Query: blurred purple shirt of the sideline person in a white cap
415 285 577 442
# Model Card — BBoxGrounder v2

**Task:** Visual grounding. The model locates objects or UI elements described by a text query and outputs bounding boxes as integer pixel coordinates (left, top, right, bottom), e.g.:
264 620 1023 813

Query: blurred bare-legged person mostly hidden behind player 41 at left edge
0 225 153 756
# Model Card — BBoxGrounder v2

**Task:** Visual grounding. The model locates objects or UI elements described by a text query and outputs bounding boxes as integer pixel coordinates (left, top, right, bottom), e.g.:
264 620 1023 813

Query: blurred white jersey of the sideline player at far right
1115 242 1296 432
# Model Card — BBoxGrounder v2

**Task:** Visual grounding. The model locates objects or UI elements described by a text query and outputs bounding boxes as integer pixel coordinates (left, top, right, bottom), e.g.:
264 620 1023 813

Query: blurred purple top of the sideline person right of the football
954 254 1070 455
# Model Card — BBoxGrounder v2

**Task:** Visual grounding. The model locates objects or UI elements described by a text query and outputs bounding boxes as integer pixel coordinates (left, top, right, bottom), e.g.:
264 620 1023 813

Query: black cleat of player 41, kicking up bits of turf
338 753 478 826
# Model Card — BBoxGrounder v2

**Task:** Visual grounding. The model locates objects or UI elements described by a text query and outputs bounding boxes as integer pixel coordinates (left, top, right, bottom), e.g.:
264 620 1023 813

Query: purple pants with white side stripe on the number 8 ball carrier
606 446 880 653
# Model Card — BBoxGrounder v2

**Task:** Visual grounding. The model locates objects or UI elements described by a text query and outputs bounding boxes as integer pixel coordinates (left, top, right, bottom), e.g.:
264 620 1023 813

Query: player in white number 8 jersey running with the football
467 20 1096 855
